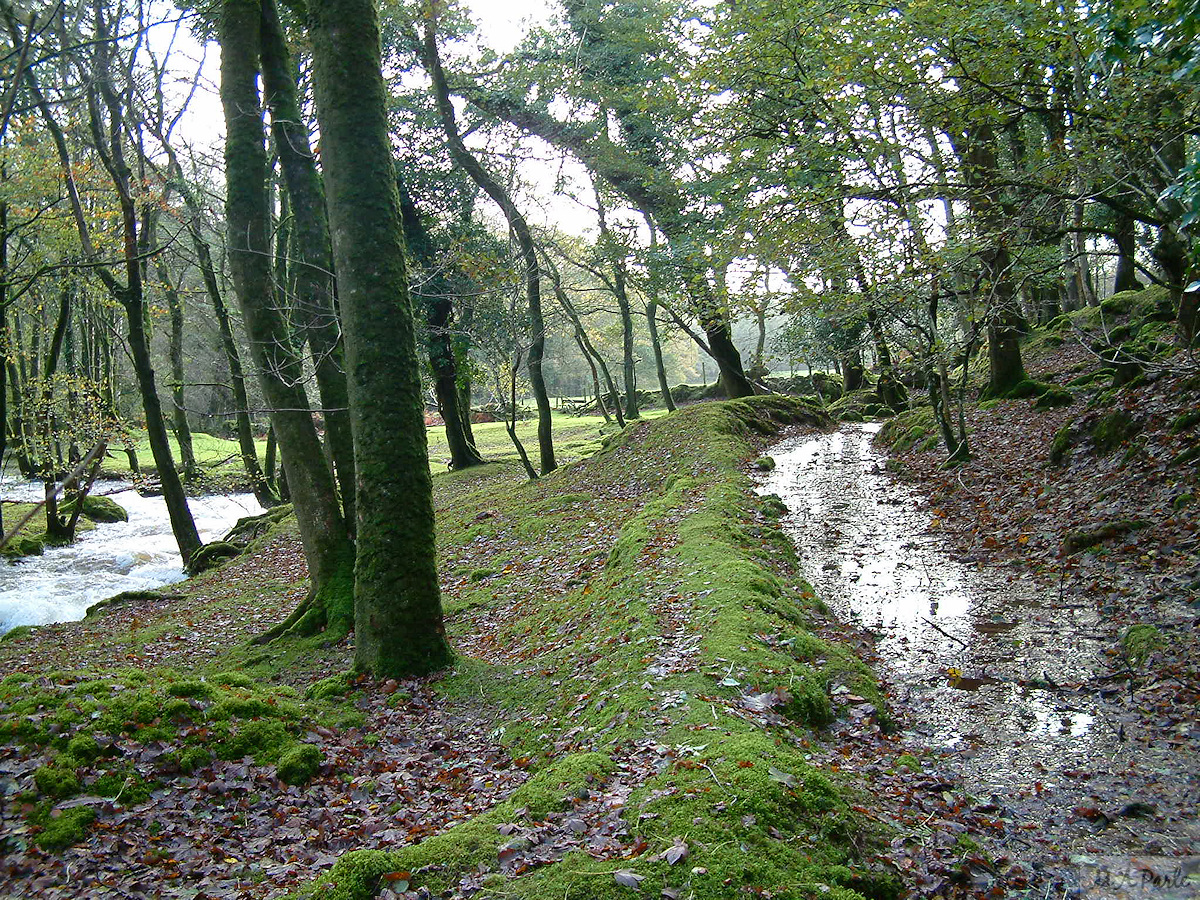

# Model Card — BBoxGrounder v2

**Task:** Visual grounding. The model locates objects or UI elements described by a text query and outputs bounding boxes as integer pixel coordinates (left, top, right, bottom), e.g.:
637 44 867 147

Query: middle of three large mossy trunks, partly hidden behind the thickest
260 0 355 534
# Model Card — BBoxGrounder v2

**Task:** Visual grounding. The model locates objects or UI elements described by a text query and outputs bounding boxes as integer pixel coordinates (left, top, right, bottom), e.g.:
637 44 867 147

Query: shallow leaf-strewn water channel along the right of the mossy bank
758 424 1200 900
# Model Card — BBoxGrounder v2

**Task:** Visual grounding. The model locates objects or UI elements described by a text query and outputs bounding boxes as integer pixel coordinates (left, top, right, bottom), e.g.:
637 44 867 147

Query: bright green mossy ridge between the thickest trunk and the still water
301 398 896 900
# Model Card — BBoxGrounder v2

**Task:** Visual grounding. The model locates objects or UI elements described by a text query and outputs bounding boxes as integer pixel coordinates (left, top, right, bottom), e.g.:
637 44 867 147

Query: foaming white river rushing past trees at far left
0 481 263 634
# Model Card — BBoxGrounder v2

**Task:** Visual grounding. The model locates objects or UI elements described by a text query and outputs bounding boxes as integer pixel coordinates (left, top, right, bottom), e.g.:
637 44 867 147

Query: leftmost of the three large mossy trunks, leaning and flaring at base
221 0 354 629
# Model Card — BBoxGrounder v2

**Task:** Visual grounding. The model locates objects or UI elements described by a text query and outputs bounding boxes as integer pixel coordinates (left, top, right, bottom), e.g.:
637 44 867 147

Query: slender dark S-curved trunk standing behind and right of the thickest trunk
422 20 558 475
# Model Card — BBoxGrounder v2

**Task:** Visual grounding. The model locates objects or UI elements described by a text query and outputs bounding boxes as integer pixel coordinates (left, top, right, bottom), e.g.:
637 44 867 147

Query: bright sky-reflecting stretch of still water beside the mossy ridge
758 424 1096 758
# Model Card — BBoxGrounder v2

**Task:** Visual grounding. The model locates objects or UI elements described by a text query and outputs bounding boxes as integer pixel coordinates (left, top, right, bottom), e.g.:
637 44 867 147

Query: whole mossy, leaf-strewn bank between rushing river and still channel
0 398 898 898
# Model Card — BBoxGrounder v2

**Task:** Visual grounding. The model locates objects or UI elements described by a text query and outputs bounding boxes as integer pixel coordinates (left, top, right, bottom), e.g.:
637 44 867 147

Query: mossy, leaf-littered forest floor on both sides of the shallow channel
0 286 1200 900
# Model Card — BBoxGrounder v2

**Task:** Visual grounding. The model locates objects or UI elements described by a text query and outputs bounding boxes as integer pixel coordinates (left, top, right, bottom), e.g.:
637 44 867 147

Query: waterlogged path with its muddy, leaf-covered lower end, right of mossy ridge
760 425 1200 898
